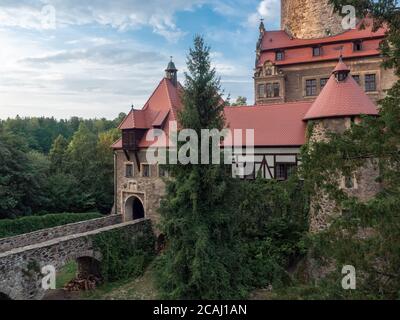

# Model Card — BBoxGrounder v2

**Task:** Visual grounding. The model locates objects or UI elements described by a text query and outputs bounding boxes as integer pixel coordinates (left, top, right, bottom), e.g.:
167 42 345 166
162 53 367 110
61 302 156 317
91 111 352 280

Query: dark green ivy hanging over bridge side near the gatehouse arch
93 221 155 282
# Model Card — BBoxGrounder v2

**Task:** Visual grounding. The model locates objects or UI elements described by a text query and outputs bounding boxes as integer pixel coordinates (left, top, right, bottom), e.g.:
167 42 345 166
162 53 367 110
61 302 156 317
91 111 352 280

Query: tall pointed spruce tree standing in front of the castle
157 37 247 299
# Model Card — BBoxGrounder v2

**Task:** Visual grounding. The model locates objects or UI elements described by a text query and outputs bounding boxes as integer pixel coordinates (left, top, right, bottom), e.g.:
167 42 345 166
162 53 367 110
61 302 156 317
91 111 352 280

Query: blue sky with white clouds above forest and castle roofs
0 0 280 119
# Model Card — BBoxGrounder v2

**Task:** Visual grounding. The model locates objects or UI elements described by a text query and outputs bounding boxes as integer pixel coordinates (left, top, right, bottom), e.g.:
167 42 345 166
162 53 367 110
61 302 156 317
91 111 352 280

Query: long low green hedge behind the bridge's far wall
0 213 102 238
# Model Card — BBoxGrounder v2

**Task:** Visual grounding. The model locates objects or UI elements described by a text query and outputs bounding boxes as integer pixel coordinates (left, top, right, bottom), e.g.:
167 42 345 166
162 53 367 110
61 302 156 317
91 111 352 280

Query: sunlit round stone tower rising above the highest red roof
281 0 344 39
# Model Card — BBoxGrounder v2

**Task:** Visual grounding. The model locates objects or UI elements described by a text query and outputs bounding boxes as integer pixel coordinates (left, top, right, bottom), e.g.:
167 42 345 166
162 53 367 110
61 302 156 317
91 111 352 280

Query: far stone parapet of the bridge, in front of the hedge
0 215 122 252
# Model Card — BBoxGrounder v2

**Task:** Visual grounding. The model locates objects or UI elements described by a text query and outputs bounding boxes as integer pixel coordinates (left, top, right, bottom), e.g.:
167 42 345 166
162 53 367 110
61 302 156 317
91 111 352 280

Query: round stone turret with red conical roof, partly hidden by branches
304 59 380 232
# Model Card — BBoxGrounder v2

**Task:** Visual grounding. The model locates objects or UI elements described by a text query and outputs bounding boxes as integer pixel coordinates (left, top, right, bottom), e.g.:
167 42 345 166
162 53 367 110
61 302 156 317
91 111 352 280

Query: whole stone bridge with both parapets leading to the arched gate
0 215 149 300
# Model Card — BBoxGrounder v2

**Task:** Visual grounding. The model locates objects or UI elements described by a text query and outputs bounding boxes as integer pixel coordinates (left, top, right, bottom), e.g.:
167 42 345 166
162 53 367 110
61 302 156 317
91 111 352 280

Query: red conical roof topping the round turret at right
304 62 378 120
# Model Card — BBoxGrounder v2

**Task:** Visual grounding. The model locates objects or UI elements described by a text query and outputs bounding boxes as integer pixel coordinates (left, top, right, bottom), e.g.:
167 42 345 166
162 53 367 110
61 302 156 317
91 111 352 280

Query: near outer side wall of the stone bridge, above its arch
0 219 150 300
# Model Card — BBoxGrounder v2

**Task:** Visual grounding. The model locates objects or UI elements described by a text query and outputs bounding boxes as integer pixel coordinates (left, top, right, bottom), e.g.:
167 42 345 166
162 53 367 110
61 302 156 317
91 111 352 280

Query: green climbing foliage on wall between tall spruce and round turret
238 176 309 288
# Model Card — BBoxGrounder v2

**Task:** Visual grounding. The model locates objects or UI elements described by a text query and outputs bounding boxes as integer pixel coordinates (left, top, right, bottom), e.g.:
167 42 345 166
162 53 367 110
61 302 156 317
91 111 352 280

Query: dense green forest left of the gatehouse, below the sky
0 113 125 219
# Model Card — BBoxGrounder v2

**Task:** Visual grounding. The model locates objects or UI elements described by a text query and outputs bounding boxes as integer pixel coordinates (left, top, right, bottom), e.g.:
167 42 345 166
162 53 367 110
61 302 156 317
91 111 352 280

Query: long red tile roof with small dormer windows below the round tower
258 22 387 67
